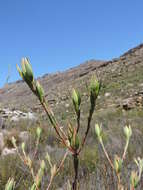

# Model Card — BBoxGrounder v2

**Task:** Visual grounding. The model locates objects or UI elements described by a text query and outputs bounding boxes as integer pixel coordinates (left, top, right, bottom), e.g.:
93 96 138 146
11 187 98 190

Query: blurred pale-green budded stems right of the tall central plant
95 124 143 190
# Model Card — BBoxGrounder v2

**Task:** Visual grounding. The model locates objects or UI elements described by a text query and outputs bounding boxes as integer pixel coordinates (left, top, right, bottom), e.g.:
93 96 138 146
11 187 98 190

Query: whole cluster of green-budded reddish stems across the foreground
2 58 143 190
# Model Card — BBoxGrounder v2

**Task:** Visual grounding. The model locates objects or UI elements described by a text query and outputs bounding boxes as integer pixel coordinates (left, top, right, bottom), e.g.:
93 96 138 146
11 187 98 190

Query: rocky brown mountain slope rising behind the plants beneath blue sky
0 44 143 110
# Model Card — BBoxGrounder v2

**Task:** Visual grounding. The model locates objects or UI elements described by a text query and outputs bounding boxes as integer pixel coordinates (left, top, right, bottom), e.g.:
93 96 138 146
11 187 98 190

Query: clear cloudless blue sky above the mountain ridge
0 0 143 86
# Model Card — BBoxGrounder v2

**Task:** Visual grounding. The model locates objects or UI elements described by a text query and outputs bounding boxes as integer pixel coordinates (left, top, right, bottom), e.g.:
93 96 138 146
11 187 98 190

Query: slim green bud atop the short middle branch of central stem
72 89 81 114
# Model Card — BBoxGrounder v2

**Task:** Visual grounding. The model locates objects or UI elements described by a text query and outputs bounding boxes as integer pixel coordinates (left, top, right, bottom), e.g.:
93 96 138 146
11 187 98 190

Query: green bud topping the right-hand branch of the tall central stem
89 76 100 104
